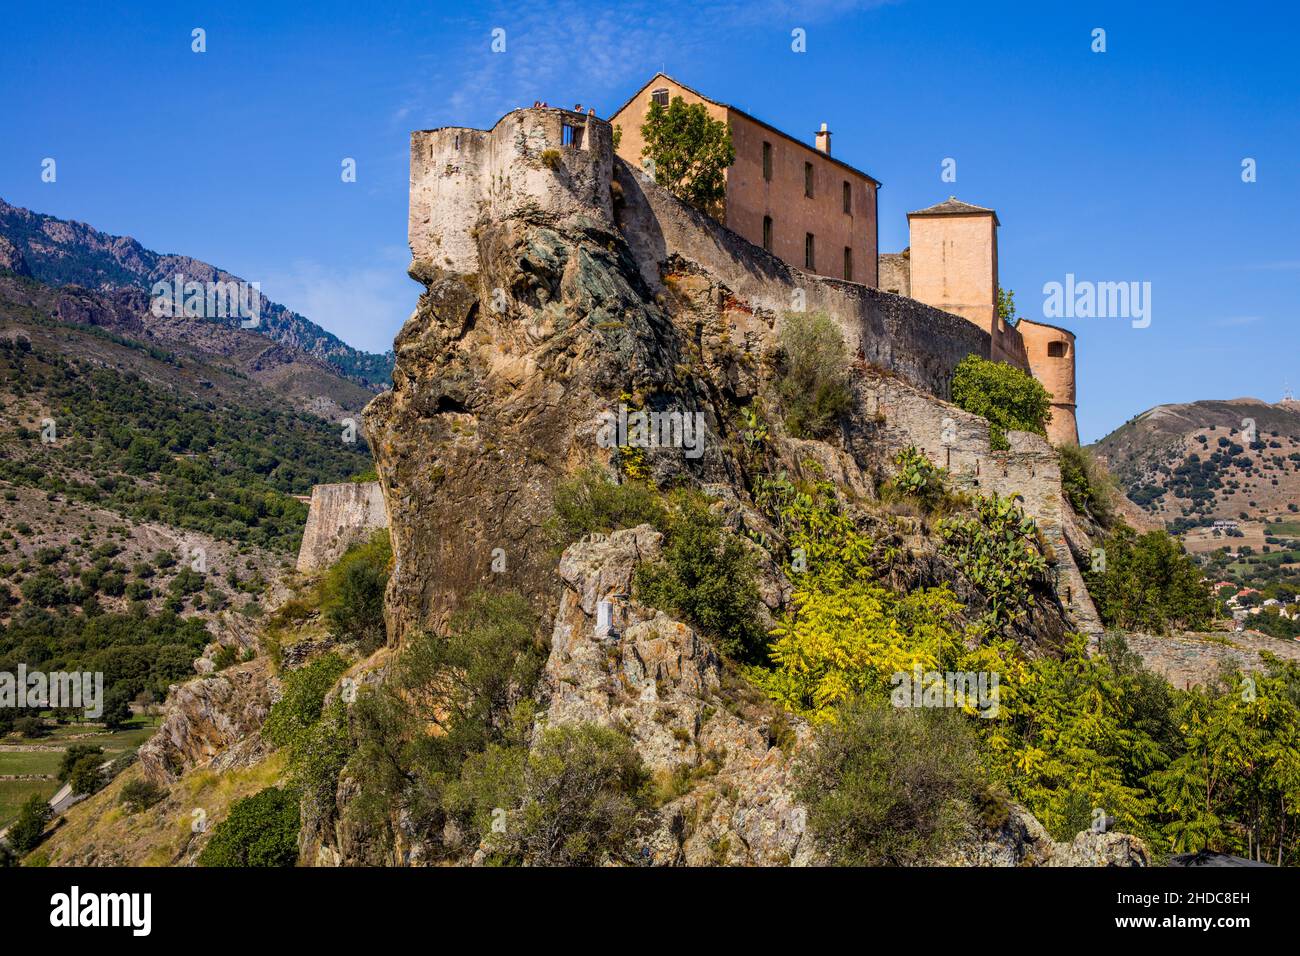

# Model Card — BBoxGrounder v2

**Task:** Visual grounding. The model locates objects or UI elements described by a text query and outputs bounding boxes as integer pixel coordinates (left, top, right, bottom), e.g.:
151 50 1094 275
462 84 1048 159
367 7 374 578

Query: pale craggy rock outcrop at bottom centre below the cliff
541 525 816 866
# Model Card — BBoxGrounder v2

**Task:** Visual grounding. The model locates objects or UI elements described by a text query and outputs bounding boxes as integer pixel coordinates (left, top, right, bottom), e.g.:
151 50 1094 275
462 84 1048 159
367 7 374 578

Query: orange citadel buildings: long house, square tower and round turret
610 73 1079 445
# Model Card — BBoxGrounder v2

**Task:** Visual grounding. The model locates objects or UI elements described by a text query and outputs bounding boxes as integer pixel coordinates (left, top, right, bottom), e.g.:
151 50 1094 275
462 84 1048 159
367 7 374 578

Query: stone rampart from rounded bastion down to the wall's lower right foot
392 108 1101 635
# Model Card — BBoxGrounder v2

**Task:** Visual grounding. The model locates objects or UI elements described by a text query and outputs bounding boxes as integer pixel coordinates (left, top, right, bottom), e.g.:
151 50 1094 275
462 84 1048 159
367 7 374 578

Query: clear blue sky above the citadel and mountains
0 0 1300 441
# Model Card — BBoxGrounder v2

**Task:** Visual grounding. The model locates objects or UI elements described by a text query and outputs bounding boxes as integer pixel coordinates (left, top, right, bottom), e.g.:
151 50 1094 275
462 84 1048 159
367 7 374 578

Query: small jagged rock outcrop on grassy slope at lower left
138 657 278 784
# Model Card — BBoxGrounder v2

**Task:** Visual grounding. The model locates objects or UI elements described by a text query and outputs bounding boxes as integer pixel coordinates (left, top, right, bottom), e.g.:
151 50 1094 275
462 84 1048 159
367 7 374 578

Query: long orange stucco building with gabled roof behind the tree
610 73 880 286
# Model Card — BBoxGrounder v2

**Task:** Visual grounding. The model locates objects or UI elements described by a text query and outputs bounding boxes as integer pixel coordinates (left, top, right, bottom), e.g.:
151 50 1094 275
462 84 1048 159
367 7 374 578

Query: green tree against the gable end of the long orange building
641 96 736 219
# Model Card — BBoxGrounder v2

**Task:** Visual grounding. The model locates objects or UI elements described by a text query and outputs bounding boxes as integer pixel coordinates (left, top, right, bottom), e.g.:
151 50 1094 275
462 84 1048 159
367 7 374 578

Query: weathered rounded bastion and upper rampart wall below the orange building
408 108 992 397
